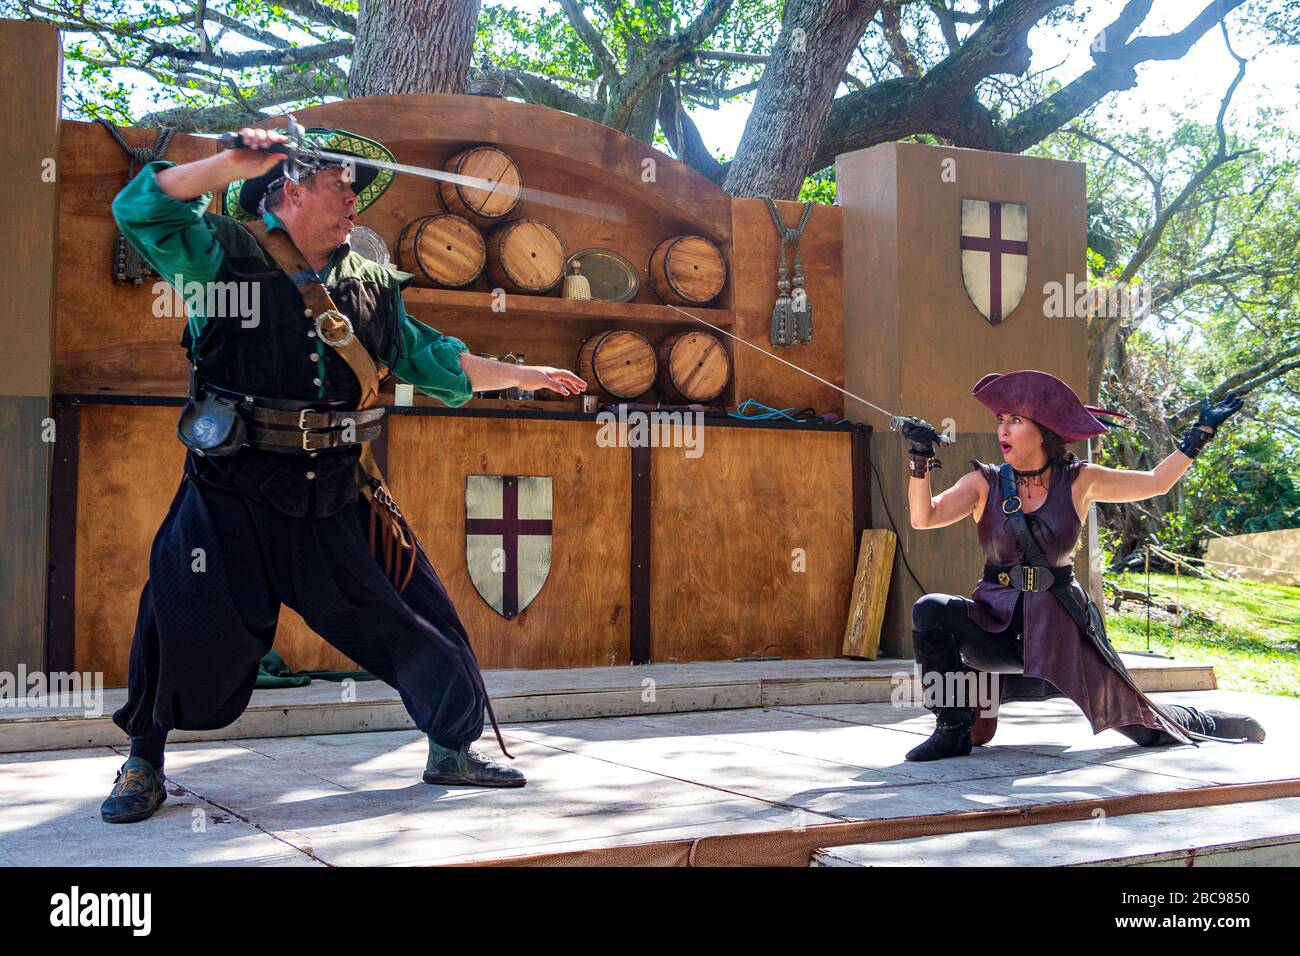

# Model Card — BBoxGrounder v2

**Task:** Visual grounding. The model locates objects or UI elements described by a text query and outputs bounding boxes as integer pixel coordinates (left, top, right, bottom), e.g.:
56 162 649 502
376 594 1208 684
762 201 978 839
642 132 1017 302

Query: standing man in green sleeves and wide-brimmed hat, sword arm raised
101 129 585 822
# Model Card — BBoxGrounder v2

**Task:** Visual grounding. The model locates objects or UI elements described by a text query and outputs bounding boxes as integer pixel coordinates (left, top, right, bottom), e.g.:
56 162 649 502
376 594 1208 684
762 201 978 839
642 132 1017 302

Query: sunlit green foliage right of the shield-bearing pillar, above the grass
1032 108 1300 554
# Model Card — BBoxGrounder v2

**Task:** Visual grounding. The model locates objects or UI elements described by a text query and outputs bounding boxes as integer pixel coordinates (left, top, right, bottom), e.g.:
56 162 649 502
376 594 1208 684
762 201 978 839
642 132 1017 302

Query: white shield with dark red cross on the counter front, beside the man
465 475 551 620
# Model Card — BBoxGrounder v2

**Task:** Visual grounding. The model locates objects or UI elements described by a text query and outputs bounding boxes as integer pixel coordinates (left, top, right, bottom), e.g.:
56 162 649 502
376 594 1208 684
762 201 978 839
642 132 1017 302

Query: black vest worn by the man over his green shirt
181 213 402 518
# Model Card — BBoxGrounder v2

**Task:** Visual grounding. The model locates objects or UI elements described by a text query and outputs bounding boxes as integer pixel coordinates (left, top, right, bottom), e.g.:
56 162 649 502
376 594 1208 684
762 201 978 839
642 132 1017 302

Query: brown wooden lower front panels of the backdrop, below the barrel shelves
57 405 866 687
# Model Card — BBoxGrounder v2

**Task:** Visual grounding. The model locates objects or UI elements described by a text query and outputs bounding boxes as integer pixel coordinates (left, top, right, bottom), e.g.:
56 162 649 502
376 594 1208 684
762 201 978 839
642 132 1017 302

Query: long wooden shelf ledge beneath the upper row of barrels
402 286 732 329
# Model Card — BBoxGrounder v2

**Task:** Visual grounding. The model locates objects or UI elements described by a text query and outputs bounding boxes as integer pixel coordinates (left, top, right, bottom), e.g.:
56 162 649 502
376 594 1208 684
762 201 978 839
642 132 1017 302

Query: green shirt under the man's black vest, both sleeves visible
113 160 473 408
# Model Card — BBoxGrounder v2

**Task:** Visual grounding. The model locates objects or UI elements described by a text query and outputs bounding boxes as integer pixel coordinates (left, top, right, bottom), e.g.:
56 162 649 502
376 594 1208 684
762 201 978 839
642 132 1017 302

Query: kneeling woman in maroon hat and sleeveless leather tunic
902 371 1264 761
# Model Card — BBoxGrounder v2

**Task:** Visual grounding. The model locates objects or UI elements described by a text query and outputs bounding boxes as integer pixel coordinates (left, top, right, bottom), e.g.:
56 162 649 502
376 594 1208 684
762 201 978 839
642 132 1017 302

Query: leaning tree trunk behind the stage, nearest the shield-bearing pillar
725 0 880 199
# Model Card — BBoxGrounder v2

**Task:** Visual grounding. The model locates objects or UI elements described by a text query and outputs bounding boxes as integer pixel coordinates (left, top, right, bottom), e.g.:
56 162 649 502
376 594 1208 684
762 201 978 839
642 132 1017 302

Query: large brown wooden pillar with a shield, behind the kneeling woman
836 143 1088 657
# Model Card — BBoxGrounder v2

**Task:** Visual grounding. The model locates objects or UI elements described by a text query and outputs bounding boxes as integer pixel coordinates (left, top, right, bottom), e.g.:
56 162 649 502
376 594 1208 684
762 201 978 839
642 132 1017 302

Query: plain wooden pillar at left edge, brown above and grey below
0 20 60 672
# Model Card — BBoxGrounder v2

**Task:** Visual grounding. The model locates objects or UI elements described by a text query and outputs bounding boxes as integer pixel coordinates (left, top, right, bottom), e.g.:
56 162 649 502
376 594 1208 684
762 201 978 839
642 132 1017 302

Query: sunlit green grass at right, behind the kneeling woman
1106 572 1300 697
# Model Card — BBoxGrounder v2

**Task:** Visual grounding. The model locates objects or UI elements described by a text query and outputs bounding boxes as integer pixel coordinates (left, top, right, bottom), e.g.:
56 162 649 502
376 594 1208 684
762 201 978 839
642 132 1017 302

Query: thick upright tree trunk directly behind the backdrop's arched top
347 0 480 98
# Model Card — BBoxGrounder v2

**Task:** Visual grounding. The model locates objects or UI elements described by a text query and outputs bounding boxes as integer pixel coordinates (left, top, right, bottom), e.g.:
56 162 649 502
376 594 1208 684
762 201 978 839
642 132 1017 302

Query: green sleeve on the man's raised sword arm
113 160 225 294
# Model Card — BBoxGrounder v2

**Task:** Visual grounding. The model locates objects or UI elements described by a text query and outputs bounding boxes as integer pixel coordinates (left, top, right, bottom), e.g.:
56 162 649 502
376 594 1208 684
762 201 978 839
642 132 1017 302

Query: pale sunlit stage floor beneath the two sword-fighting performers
0 662 1300 866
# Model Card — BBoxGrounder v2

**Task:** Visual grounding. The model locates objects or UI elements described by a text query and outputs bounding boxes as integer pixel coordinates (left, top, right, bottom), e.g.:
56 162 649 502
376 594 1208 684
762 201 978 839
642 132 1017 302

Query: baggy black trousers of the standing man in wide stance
113 475 486 747
